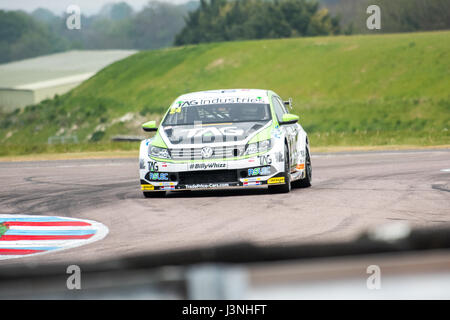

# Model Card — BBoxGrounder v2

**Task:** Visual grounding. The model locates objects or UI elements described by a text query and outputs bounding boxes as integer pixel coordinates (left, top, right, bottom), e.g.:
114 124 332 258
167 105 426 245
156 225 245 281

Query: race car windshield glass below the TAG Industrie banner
163 103 271 126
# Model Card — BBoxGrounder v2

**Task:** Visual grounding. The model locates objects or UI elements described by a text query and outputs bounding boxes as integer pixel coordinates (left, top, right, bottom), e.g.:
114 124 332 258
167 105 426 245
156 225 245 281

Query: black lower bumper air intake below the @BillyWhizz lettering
178 170 238 184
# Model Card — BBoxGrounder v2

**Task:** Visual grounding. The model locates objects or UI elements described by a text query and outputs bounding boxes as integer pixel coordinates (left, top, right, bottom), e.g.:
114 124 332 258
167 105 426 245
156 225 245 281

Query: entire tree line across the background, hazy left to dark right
0 0 450 63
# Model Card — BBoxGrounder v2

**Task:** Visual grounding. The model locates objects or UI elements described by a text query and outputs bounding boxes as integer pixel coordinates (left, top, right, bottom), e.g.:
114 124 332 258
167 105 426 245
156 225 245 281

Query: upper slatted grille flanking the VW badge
170 146 245 160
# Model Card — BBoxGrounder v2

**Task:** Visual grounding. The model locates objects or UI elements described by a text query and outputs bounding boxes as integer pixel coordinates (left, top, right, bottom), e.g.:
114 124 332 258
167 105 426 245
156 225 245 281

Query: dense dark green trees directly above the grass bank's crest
175 0 340 45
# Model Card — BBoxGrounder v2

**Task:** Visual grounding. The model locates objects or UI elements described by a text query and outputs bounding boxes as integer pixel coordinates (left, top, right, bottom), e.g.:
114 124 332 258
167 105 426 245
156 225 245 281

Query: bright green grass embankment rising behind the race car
0 31 450 156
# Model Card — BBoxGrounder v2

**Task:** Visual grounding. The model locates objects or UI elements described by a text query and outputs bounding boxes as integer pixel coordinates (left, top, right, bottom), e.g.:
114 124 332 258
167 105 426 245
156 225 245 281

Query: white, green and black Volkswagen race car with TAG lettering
139 89 312 197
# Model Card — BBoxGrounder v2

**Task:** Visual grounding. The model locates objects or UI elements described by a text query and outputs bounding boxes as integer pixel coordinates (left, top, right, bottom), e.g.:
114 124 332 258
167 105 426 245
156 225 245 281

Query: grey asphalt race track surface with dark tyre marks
0 149 450 265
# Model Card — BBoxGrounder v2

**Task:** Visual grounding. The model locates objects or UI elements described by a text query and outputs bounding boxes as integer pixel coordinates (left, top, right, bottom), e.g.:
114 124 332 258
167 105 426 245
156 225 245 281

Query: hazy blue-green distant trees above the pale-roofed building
0 1 198 63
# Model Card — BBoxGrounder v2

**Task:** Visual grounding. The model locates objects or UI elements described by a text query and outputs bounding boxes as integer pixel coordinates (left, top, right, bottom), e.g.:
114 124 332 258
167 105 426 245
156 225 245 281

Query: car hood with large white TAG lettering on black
161 121 269 145
